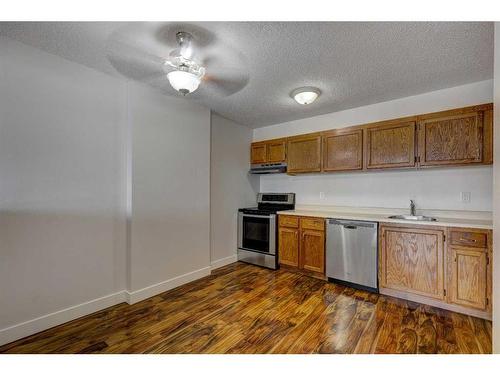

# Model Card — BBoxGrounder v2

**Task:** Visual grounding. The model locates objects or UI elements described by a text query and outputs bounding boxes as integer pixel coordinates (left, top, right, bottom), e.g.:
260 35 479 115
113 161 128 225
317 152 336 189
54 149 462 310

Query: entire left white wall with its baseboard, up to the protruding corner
0 37 210 344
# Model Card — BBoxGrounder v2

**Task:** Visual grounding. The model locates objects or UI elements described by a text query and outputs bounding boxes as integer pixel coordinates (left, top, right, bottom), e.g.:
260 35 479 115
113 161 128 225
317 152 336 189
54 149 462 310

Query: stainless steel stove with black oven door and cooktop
238 193 295 269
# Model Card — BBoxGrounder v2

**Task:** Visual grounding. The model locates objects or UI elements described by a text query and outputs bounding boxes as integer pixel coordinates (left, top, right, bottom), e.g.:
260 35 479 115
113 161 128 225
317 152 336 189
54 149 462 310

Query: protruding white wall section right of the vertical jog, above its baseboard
129 85 210 292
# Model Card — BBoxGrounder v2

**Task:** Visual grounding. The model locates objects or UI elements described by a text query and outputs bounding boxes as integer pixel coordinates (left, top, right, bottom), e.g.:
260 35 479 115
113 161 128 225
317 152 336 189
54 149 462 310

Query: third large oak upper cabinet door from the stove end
365 121 416 169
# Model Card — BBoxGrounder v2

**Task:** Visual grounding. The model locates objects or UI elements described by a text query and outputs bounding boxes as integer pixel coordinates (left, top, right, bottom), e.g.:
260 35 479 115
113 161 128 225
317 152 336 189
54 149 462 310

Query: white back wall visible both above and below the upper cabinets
260 81 493 211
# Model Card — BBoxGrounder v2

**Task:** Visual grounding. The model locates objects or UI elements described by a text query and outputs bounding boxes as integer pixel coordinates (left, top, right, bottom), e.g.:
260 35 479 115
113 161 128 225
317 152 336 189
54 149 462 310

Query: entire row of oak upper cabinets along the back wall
251 103 493 174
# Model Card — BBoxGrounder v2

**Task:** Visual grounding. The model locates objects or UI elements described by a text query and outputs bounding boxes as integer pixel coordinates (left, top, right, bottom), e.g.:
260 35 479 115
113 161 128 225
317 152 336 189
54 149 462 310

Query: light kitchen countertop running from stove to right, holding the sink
278 207 493 229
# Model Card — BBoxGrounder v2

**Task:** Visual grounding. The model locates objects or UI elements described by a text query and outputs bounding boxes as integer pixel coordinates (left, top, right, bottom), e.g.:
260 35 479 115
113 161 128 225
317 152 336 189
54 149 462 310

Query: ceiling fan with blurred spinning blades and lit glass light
106 23 248 100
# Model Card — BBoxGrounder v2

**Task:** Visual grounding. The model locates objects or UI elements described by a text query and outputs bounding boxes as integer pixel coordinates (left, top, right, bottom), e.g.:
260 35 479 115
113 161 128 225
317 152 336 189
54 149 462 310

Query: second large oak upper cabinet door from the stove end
323 129 363 171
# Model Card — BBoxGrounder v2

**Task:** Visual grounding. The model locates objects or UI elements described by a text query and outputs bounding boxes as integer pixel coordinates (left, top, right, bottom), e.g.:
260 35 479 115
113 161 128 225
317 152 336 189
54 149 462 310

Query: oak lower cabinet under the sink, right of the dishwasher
379 224 492 319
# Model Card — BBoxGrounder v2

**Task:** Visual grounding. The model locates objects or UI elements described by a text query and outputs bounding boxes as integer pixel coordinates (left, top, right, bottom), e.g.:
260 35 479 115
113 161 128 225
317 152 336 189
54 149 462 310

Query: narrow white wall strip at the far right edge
492 22 500 354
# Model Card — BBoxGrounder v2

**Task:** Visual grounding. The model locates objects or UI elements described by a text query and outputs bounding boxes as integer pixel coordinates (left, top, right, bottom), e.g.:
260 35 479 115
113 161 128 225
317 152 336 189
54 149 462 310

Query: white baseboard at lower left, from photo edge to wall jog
0 291 126 345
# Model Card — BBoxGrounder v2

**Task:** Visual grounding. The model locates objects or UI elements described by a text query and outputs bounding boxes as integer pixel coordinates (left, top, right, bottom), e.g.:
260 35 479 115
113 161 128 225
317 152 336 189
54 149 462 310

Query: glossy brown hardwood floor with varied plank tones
0 263 491 353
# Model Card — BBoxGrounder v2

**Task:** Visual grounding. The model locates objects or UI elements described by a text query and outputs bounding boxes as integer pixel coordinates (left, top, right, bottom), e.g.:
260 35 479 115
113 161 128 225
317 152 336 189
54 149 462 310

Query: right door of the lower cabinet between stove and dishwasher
300 229 325 273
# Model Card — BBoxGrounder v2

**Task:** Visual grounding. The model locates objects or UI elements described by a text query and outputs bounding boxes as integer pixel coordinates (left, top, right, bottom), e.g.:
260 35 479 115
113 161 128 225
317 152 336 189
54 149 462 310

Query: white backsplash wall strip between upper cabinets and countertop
260 166 493 211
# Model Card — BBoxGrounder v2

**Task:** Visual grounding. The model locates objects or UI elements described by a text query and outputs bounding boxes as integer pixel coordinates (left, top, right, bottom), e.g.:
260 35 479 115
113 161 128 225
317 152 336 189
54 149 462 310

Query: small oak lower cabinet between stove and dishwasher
278 215 325 278
